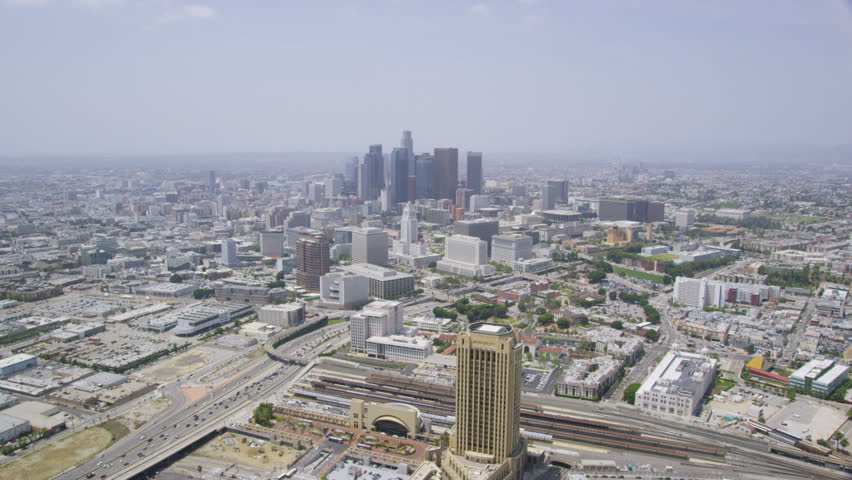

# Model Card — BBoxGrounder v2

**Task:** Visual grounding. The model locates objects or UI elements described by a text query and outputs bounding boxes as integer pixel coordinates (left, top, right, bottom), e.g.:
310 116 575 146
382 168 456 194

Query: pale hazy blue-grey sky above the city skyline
0 0 852 154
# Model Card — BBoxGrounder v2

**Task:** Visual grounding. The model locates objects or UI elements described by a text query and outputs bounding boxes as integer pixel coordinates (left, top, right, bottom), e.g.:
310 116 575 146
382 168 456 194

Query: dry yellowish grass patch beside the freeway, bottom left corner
0 427 113 480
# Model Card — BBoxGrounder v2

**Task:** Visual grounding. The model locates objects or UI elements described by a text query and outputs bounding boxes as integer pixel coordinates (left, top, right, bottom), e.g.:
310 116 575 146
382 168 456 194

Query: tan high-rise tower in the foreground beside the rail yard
442 322 526 480
